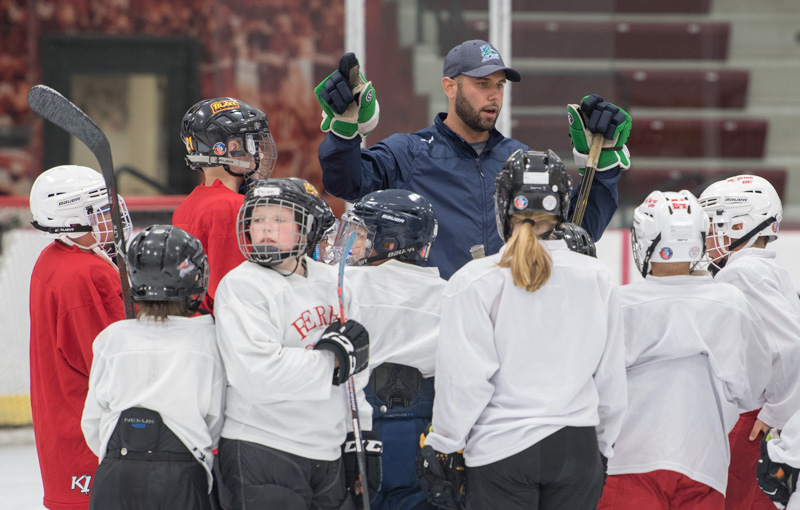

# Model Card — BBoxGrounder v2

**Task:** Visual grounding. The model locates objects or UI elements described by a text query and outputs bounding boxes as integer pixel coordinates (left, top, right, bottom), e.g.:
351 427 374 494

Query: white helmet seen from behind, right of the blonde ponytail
631 190 708 276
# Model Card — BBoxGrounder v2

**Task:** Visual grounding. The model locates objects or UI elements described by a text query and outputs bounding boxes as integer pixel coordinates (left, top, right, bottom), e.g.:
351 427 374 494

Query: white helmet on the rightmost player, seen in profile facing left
700 175 783 267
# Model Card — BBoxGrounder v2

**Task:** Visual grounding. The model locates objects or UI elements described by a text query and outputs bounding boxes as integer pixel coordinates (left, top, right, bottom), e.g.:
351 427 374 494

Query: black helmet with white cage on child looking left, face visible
236 177 335 267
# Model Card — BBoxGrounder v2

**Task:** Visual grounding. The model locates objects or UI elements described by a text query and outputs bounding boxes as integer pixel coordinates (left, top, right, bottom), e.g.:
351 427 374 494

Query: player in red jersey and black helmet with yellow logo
172 97 278 313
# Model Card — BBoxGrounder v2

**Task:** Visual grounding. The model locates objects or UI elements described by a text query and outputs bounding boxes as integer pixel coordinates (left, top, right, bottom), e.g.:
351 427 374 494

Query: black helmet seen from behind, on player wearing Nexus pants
126 225 208 312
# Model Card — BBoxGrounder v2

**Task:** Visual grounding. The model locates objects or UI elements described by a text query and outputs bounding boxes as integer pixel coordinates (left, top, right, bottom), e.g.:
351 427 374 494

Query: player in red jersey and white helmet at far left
30 165 131 510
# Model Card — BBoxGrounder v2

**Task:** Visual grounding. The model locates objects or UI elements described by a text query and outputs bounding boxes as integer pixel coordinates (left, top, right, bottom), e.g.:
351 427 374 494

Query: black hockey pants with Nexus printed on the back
89 407 211 510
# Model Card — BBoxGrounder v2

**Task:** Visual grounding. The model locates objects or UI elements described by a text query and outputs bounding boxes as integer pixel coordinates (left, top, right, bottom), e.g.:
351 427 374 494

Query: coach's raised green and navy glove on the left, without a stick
314 53 381 139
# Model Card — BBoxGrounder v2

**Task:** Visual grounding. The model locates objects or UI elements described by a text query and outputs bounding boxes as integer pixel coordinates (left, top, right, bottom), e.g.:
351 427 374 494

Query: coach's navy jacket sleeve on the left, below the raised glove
319 133 412 200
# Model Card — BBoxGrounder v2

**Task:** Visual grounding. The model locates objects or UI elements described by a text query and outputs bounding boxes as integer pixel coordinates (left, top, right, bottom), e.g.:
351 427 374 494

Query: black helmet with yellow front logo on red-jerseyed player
181 97 278 179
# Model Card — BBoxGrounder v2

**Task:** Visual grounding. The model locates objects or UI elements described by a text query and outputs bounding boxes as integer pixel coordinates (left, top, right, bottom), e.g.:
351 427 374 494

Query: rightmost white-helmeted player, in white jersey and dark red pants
700 175 800 510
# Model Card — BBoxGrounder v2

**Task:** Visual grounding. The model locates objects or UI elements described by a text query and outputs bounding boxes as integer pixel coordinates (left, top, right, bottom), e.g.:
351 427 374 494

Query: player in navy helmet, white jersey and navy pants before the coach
334 189 447 510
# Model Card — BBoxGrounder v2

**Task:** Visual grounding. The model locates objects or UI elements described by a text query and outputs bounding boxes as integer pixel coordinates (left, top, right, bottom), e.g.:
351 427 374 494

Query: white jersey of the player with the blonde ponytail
426 241 627 466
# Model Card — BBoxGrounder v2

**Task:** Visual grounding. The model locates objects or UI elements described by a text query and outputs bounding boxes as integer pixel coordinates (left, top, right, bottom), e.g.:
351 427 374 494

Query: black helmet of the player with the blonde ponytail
494 149 572 241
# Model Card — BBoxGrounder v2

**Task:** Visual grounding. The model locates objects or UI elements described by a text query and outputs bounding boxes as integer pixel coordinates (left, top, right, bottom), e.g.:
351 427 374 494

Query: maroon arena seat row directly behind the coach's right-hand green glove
512 117 767 158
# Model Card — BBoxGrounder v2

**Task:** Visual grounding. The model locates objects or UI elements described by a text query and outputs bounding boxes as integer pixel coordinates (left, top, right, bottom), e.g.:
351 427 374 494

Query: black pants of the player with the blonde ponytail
466 427 605 510
